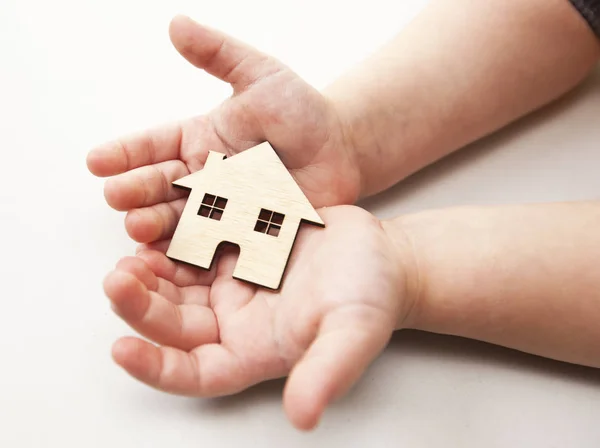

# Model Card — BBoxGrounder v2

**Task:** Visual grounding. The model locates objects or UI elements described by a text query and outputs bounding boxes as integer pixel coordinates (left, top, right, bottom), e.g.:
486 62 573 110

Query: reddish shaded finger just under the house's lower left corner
137 249 216 288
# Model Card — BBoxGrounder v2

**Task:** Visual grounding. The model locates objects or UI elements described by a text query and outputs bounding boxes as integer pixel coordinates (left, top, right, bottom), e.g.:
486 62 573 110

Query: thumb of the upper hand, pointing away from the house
169 16 283 91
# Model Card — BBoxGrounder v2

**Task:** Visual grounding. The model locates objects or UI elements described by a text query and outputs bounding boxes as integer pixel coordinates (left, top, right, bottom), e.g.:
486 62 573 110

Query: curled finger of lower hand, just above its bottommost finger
104 270 218 350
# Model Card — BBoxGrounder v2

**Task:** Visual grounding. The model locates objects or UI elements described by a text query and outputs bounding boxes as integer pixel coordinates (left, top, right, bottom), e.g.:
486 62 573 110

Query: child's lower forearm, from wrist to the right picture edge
384 202 600 367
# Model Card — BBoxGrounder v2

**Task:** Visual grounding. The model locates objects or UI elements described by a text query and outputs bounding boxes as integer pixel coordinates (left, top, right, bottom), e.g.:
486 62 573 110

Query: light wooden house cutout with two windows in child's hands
167 142 325 289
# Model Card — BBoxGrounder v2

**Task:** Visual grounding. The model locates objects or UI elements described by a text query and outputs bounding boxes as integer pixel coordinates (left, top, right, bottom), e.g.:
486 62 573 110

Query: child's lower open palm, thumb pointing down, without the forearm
105 206 412 429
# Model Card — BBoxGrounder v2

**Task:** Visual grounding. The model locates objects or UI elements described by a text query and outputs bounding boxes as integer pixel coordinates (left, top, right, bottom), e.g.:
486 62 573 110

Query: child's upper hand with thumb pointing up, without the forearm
88 17 360 243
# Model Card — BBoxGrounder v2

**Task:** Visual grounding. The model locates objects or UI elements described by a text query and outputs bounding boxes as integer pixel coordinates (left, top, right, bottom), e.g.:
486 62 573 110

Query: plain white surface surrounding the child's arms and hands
0 0 600 448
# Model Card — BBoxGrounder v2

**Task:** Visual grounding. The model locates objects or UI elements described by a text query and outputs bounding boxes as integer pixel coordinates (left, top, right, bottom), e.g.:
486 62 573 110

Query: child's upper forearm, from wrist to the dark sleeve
324 0 600 196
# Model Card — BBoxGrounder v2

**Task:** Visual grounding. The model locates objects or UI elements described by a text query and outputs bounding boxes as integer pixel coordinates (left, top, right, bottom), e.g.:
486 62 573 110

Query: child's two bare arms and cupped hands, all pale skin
88 0 600 430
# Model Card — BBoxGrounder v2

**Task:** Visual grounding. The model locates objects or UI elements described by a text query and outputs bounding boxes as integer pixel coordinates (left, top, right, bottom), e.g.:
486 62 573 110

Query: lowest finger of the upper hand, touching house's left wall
125 198 186 243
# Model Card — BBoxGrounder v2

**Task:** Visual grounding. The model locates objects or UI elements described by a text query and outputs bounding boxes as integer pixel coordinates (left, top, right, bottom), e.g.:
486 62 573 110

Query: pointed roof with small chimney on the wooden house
173 142 325 226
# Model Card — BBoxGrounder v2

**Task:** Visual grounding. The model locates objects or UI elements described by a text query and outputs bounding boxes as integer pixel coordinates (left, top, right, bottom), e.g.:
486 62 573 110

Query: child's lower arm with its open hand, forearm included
104 202 600 429
